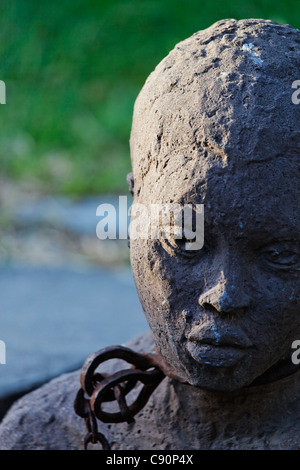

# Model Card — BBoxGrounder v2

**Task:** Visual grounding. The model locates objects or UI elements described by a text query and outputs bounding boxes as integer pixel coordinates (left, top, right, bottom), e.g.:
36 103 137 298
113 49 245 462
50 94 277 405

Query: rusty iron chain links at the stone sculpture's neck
74 346 183 450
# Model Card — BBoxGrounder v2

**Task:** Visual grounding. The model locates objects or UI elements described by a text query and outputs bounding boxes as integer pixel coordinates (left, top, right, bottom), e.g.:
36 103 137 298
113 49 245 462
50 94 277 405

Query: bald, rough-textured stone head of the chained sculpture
130 19 300 391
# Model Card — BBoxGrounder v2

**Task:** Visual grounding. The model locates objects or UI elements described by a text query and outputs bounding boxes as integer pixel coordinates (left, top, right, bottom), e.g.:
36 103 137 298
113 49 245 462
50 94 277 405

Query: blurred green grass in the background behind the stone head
0 0 300 196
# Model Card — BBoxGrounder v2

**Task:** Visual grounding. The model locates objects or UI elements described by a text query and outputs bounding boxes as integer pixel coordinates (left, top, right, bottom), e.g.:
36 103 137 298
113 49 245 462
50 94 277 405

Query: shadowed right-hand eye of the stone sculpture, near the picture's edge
262 242 300 270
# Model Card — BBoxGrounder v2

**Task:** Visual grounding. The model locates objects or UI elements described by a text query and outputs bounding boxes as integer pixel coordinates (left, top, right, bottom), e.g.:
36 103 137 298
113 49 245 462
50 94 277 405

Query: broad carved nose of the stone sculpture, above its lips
199 272 250 314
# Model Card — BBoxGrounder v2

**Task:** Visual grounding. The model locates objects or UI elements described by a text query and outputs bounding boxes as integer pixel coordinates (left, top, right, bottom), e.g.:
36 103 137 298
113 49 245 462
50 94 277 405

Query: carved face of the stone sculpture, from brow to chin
131 152 300 390
